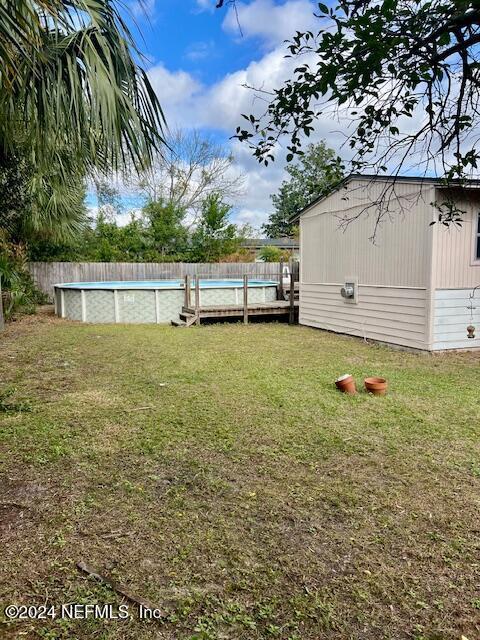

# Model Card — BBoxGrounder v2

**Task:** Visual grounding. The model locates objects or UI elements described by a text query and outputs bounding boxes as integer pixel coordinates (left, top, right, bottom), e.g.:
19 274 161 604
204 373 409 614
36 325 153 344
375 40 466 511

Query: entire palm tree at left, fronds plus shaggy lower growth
0 0 165 320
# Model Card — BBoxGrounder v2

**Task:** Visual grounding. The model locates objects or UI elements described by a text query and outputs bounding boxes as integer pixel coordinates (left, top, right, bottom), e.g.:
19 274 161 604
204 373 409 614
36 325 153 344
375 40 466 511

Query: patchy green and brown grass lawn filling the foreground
0 308 480 640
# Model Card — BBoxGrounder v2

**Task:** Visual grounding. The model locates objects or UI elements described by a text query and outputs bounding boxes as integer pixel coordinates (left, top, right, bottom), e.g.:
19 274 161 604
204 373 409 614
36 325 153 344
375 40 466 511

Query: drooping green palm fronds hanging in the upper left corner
0 0 165 171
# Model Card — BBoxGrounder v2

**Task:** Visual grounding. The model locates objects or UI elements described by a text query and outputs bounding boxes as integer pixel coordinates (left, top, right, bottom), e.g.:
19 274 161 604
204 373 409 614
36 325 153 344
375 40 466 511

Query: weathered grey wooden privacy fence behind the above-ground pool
28 262 298 299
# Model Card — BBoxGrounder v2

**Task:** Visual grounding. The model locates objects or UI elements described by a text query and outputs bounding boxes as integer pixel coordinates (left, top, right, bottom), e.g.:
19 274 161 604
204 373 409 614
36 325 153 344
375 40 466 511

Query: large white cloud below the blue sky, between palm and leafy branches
144 40 343 227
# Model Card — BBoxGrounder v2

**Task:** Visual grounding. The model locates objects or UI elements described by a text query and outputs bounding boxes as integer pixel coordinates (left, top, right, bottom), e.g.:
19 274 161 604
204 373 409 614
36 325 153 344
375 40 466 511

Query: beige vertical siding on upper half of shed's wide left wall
300 181 434 287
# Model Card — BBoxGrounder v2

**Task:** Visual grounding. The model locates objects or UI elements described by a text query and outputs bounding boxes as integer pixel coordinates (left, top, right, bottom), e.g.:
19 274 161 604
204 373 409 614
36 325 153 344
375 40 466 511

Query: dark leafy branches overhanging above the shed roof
227 0 480 221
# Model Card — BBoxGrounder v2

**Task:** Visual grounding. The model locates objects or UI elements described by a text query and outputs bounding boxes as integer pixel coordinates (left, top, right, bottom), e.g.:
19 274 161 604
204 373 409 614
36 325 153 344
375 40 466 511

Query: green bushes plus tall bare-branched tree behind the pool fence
23 130 251 262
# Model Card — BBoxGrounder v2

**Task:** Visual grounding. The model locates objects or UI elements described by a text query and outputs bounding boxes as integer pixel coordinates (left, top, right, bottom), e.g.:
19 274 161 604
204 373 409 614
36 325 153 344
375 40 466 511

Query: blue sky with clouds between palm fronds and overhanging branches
87 0 339 229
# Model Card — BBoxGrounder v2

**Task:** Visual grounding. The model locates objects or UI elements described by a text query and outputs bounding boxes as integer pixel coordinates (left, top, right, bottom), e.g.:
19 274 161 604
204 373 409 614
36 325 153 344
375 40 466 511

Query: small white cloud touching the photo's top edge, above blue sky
223 0 316 47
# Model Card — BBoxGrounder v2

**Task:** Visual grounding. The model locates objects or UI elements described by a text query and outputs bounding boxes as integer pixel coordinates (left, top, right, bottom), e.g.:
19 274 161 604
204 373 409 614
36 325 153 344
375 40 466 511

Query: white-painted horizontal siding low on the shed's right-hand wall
432 288 480 351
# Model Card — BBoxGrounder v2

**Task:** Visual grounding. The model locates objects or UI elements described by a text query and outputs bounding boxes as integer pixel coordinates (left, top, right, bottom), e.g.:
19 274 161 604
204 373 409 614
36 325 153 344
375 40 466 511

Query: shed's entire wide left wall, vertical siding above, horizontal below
299 181 434 349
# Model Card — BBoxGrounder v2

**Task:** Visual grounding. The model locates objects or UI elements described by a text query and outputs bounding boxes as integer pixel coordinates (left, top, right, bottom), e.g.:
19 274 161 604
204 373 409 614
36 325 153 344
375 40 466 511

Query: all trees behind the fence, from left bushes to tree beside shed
28 137 343 262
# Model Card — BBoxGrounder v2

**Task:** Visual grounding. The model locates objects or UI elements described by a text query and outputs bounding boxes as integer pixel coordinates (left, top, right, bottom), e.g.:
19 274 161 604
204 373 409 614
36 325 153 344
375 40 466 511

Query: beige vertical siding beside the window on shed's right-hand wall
432 192 480 288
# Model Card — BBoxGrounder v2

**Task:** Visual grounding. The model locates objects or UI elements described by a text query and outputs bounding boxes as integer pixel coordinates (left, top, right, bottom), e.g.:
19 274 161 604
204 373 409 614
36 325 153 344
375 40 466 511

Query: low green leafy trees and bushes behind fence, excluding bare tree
31 193 249 262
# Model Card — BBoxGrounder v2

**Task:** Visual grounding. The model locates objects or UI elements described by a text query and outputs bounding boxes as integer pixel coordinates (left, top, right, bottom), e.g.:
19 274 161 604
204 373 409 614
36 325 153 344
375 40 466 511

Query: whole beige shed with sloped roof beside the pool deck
298 175 480 351
